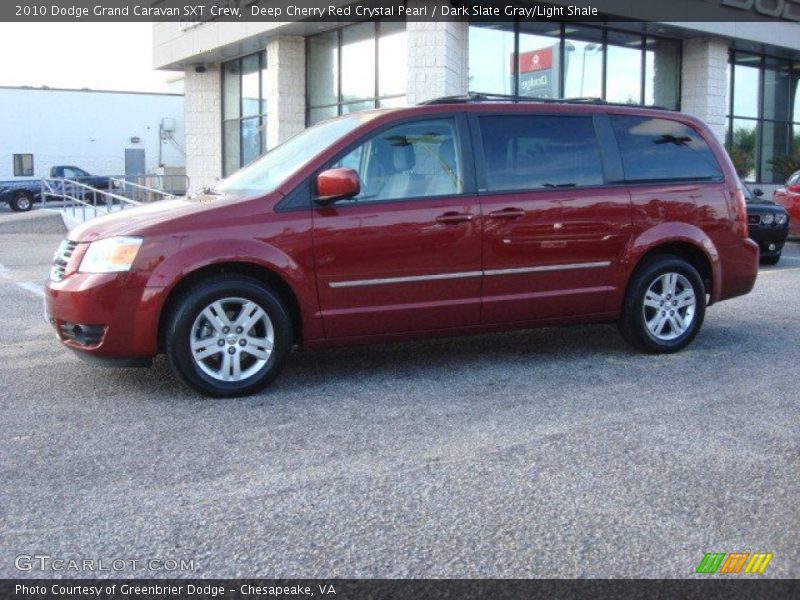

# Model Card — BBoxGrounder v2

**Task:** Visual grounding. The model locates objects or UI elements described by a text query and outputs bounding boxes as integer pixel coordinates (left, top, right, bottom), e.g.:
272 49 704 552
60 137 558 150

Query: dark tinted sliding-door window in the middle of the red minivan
478 115 603 192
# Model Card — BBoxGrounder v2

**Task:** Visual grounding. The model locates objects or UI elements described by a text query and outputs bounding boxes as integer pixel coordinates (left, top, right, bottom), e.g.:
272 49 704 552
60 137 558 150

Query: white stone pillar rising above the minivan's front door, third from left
406 8 469 105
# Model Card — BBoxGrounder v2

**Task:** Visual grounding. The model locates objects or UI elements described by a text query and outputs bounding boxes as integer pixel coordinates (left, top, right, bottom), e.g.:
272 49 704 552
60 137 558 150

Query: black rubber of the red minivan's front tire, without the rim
165 276 292 398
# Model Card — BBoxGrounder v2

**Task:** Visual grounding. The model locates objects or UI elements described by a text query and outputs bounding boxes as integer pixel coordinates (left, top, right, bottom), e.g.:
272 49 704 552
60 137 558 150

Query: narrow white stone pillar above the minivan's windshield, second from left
266 36 306 149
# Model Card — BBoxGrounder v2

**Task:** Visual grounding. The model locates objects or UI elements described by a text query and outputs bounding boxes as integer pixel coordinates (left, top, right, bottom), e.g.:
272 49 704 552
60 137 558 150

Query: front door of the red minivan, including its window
313 116 481 338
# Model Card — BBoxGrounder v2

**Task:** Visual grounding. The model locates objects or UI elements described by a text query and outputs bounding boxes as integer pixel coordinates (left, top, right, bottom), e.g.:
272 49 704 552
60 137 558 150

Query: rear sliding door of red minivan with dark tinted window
474 114 631 323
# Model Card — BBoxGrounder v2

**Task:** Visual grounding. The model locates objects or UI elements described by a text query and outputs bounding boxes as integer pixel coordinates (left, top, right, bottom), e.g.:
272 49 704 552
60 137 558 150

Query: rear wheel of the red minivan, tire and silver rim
618 255 706 354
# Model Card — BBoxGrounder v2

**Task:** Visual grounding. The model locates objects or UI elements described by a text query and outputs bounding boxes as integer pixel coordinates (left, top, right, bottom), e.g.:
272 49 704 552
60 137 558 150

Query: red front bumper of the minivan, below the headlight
45 273 161 364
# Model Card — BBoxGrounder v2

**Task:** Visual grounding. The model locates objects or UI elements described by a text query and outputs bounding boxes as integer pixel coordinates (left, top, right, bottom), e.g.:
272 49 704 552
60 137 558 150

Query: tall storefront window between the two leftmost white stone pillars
222 52 267 176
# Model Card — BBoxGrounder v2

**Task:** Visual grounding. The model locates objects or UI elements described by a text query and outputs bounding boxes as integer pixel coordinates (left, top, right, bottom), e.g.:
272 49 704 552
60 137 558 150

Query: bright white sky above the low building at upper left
0 22 176 92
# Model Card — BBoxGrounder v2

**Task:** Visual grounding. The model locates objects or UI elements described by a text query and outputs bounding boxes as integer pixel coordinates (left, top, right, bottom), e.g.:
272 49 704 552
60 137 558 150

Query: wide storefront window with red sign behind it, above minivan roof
469 21 681 109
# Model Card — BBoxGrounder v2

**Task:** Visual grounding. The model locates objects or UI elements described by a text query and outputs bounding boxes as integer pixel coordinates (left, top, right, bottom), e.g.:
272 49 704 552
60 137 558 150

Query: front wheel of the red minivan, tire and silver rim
164 275 293 398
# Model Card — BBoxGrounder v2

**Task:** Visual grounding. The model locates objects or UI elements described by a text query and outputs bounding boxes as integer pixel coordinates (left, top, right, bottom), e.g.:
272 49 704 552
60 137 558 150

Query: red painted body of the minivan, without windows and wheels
46 103 756 359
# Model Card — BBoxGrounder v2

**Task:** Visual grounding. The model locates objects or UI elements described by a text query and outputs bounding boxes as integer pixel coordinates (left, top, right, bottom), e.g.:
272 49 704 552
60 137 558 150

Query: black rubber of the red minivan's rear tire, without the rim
624 257 706 353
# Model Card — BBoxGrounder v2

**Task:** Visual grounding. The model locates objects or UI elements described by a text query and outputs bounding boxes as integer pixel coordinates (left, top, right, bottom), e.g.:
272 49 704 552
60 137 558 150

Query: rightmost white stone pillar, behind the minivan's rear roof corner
681 37 728 142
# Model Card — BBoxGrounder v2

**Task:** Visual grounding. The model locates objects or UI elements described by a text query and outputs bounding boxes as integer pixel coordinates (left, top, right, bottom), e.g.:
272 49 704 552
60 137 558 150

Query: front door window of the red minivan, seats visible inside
332 118 464 202
